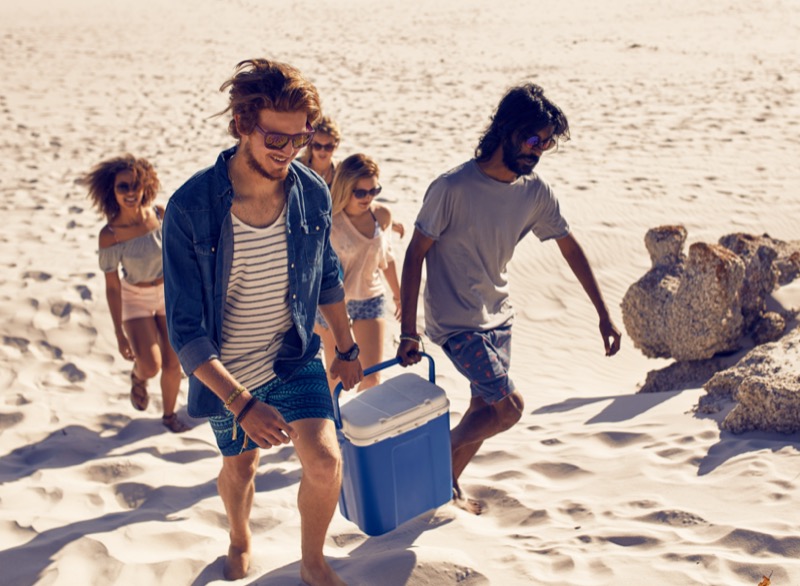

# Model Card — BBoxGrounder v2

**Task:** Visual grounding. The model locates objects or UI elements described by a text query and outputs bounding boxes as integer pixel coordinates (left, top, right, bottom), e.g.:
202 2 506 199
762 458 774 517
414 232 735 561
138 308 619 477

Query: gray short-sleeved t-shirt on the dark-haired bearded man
415 160 569 345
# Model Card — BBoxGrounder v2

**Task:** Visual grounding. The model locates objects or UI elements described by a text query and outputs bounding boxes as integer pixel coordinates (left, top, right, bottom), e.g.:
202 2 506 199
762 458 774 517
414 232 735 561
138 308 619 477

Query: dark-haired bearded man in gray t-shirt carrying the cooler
397 83 621 514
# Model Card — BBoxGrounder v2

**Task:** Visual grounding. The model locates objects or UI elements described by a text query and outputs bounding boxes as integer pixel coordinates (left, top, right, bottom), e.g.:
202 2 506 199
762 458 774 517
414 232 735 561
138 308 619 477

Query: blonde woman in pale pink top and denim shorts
314 154 400 391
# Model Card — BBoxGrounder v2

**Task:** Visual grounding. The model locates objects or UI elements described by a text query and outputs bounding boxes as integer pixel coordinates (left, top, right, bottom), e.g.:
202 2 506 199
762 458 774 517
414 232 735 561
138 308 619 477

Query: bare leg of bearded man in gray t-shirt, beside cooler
450 391 525 515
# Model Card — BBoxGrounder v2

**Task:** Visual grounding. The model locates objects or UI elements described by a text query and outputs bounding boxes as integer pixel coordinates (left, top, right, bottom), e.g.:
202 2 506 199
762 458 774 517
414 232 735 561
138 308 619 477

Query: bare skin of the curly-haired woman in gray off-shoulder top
99 171 181 424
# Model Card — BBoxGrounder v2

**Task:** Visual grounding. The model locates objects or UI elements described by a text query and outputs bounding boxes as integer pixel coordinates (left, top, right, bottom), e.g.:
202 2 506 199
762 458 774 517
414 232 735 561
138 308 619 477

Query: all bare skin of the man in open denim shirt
194 110 363 586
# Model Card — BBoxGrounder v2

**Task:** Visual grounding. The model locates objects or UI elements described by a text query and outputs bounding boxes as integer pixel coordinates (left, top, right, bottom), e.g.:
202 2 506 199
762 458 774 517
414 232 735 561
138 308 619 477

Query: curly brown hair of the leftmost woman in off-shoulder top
80 154 161 221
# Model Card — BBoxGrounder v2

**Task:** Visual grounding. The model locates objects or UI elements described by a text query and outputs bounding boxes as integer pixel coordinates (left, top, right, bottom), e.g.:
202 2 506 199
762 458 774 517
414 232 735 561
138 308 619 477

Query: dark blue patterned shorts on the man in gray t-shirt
442 326 516 403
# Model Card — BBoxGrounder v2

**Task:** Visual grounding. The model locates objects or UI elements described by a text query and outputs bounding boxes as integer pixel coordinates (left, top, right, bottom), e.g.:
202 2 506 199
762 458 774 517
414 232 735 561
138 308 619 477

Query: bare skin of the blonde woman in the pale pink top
314 177 400 391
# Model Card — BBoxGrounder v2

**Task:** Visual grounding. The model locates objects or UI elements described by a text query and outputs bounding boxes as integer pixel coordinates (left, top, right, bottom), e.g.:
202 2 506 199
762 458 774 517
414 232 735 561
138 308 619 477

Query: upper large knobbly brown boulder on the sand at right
622 226 800 361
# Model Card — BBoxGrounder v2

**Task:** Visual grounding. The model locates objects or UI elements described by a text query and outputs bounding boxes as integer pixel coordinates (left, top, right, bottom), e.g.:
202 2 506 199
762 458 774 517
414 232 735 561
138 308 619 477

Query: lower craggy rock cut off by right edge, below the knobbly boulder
697 327 800 433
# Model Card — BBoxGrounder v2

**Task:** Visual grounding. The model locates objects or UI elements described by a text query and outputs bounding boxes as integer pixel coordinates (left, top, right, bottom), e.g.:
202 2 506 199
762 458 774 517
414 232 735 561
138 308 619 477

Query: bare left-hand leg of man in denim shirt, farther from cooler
217 449 259 580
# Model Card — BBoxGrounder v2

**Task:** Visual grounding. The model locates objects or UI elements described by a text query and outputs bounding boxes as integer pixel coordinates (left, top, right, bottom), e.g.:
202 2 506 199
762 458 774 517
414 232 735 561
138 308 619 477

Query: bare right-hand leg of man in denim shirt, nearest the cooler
292 419 346 586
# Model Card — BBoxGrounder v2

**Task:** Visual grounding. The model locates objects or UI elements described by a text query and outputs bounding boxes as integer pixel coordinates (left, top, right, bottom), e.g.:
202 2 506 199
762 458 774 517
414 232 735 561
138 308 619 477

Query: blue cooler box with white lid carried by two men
333 354 453 535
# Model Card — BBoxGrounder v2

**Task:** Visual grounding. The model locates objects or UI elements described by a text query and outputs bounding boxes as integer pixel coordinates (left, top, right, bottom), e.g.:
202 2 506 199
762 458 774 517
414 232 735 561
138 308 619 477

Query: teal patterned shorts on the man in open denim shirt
208 358 333 456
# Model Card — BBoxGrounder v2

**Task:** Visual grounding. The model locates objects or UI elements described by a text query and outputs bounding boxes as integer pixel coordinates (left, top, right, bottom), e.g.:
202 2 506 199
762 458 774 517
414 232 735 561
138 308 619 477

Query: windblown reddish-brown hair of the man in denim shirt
219 59 322 139
